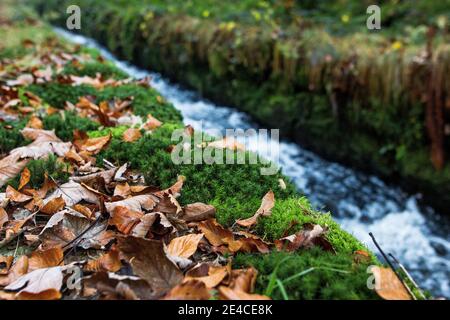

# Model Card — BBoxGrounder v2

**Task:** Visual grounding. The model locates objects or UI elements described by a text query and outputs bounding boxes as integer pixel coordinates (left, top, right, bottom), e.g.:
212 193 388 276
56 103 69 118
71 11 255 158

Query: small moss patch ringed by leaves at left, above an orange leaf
43 111 100 141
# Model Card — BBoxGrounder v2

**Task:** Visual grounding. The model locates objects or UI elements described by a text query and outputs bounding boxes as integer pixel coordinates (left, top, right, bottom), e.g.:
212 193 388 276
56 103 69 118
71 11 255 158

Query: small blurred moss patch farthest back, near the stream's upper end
62 62 128 79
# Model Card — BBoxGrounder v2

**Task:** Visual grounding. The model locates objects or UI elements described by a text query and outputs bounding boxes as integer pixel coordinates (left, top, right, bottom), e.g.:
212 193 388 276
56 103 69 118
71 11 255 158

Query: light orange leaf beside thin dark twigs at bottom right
371 266 411 300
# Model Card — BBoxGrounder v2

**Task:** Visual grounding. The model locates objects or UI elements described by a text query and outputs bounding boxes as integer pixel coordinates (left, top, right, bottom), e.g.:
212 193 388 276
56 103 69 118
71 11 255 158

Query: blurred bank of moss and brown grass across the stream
29 0 450 213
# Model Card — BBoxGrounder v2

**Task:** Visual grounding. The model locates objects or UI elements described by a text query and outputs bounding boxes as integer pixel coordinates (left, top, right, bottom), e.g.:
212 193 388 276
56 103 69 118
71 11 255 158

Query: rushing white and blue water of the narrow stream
56 29 450 298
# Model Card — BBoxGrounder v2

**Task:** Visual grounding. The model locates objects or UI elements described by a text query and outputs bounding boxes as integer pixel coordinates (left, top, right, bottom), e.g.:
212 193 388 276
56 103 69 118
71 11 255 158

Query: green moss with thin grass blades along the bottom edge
233 249 377 300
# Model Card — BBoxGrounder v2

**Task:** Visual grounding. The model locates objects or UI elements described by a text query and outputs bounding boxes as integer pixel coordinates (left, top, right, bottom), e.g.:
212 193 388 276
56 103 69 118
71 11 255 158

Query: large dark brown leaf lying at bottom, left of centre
118 236 183 296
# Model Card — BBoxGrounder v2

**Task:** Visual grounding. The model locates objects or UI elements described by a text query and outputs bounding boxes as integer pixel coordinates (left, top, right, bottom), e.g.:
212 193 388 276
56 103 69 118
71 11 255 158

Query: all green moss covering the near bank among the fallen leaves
0 4 384 299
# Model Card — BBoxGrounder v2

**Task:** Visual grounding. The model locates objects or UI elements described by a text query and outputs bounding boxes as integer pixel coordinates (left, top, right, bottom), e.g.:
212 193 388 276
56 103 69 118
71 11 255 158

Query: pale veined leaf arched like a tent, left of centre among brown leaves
44 181 99 207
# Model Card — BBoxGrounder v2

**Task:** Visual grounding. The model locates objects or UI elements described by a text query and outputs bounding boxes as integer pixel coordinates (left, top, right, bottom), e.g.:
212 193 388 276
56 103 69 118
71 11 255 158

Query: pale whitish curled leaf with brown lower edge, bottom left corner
5 267 64 300
